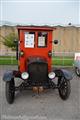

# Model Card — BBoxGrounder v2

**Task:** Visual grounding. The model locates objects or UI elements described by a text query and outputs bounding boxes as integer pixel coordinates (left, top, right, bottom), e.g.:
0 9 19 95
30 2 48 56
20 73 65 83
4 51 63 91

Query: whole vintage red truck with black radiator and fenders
3 26 72 104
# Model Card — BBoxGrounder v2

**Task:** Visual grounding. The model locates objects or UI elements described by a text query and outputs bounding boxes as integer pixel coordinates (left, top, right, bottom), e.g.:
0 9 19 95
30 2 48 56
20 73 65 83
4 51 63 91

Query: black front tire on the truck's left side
5 78 15 104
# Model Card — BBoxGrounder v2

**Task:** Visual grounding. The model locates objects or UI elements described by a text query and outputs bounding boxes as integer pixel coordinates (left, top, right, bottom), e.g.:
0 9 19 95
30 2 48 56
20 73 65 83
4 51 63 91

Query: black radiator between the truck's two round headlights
28 62 48 86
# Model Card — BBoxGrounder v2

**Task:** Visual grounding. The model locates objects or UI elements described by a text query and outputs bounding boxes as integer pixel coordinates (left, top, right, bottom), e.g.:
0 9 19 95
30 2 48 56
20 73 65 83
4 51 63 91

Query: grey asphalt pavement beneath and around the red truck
0 65 80 120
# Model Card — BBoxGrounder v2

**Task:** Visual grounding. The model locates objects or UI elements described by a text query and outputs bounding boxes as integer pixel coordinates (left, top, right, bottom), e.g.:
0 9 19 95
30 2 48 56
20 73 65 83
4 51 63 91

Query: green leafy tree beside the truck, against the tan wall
3 33 18 50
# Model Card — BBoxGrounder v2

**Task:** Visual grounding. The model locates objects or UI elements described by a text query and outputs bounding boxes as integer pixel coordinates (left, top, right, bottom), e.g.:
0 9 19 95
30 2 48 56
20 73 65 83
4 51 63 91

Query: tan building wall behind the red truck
0 25 80 55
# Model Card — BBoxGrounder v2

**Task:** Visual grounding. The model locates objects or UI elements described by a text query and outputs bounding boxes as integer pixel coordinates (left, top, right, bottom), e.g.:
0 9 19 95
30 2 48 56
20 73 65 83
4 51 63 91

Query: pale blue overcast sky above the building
0 0 80 25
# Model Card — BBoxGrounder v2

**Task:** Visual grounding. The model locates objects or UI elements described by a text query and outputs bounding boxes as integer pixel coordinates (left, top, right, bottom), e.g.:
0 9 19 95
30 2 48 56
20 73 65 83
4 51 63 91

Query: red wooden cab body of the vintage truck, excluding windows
17 26 53 72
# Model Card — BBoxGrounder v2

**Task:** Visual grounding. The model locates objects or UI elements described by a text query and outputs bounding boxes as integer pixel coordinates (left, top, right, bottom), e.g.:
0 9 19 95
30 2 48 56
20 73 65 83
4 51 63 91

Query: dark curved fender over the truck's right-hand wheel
54 69 73 80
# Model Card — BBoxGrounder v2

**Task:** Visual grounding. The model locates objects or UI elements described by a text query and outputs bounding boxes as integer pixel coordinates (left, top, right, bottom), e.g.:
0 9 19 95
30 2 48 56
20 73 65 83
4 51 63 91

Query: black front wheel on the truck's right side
58 77 71 100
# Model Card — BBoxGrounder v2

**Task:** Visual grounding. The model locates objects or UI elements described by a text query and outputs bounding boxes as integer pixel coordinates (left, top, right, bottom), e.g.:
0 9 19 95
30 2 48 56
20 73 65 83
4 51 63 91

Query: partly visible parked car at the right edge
74 53 80 76
